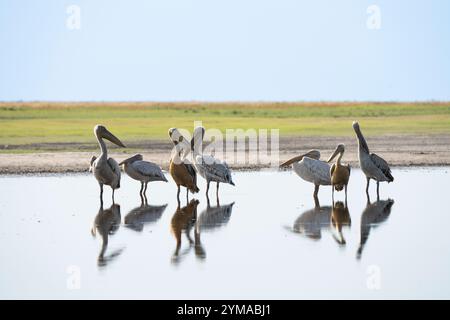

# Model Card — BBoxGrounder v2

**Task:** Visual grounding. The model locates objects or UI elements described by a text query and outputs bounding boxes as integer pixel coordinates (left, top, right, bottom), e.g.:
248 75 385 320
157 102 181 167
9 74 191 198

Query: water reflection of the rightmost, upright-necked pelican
356 199 394 259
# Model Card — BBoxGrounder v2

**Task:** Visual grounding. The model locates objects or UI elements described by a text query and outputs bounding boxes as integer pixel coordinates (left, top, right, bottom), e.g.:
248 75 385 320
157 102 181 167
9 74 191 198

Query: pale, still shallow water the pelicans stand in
0 167 450 299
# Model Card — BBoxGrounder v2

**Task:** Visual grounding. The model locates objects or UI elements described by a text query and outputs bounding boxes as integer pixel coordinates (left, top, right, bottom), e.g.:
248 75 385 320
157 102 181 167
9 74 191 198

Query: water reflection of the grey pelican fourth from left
195 199 234 259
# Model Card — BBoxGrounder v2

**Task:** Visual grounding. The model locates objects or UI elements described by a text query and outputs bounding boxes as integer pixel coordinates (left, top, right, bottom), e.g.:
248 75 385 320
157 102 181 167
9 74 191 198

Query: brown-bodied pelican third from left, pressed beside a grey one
169 128 200 202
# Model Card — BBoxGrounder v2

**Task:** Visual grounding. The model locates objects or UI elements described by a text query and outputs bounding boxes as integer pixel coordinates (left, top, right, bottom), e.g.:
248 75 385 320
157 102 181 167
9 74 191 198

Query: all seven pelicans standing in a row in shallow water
90 122 394 203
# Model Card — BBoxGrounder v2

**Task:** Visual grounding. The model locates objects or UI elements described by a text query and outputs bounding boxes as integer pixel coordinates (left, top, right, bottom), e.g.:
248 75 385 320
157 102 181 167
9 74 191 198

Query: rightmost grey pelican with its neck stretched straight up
353 121 394 197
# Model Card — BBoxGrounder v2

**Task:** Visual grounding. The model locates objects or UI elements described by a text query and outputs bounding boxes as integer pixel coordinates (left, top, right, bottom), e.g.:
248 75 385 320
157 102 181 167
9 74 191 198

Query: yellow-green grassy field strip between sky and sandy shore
0 102 450 152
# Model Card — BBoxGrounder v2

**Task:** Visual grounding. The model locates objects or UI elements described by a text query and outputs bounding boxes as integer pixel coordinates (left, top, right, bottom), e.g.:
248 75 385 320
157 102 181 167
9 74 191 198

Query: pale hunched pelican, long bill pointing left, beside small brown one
280 150 331 199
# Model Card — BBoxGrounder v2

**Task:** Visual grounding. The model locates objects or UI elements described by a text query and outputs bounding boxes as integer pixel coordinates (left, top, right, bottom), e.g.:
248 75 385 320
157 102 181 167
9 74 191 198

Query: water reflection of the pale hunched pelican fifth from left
293 200 331 240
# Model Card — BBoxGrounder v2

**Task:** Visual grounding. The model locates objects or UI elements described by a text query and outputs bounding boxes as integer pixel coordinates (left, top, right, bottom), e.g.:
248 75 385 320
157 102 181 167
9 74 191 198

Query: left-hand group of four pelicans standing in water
89 125 234 203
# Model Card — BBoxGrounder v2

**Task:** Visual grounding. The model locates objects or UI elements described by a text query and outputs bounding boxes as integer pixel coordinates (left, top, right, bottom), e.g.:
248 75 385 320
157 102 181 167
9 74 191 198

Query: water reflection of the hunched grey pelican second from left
124 199 167 232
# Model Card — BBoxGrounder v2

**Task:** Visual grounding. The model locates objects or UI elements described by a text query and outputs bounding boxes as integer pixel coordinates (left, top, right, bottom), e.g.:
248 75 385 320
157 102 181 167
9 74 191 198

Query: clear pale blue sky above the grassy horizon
0 0 450 101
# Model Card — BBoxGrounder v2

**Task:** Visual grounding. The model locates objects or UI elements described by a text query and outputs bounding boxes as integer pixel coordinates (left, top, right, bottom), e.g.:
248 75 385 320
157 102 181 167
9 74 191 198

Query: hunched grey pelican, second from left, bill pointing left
119 154 167 198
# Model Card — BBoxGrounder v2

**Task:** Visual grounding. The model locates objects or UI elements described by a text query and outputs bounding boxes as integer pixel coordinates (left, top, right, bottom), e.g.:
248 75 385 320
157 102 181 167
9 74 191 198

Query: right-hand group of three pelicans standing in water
280 121 394 203
